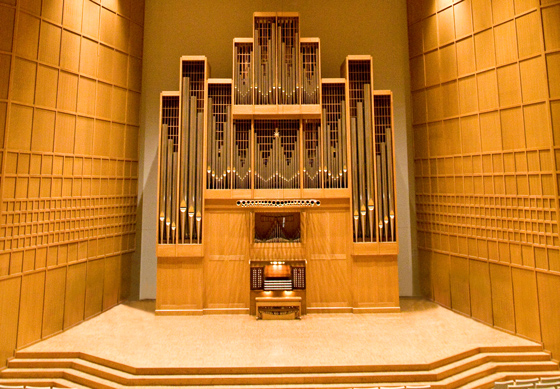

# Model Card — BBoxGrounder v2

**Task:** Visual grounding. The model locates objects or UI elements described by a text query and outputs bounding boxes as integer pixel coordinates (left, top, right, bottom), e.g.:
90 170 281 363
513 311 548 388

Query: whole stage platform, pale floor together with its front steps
0 299 558 389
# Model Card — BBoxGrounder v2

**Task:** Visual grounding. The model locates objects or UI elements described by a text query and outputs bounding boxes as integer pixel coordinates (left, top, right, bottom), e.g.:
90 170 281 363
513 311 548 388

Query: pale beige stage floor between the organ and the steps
24 299 535 367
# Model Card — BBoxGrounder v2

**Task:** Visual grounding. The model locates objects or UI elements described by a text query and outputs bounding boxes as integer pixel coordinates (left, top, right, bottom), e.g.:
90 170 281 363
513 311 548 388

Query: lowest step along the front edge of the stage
0 360 558 389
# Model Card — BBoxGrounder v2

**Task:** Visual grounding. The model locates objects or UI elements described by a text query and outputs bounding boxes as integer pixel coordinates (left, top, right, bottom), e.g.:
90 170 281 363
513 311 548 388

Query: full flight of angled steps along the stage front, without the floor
0 346 559 389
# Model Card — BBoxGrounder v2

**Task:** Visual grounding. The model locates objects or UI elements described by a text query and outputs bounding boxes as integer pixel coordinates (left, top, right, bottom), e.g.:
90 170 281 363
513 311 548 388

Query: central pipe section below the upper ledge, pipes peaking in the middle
255 120 300 189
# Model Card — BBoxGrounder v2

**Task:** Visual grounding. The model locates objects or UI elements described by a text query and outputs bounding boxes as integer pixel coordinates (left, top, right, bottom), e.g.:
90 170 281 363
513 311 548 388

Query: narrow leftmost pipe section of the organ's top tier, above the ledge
234 43 253 104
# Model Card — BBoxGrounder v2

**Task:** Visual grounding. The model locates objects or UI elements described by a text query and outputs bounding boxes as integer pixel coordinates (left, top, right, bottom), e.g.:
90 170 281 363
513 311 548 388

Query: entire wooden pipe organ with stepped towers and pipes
156 13 399 315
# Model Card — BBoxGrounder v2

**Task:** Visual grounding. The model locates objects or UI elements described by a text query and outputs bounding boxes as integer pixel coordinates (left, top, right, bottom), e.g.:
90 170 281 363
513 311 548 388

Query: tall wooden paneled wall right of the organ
408 0 560 360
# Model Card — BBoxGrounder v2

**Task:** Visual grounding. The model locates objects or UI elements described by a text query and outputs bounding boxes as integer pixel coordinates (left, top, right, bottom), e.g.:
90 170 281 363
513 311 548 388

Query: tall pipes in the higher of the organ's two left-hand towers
179 71 204 244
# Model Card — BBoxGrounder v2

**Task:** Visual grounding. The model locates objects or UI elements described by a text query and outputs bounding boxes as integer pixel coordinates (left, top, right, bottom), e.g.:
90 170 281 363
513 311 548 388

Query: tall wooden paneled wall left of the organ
0 0 144 367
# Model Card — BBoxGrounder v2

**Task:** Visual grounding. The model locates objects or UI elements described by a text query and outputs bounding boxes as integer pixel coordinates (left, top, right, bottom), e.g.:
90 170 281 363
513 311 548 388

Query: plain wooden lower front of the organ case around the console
156 207 399 314
